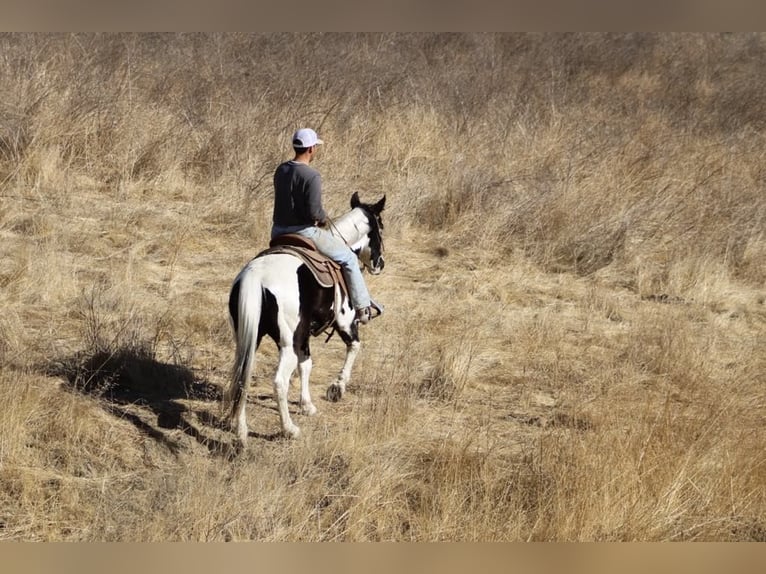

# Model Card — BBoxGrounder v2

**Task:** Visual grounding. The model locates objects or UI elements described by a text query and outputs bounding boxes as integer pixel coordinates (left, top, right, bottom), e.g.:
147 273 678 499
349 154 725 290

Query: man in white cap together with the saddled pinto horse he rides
224 129 386 448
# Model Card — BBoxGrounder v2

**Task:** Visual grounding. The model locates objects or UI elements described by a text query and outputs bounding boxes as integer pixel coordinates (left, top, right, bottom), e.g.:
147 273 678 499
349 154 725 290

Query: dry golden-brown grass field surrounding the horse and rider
0 34 766 541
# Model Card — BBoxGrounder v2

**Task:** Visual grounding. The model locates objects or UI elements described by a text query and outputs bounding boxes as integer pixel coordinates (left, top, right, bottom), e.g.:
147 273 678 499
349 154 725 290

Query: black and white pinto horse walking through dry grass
224 192 386 447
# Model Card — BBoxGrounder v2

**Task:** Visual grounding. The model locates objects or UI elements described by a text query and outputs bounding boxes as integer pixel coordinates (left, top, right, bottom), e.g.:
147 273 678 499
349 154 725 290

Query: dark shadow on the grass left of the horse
45 347 243 456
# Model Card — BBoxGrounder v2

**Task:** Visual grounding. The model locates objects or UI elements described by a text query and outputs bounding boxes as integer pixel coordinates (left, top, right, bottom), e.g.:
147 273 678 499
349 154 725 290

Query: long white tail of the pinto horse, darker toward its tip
226 267 263 435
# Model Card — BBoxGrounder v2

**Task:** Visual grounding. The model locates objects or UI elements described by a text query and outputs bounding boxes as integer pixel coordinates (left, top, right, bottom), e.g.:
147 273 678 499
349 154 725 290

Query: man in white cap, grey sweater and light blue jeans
271 128 372 323
